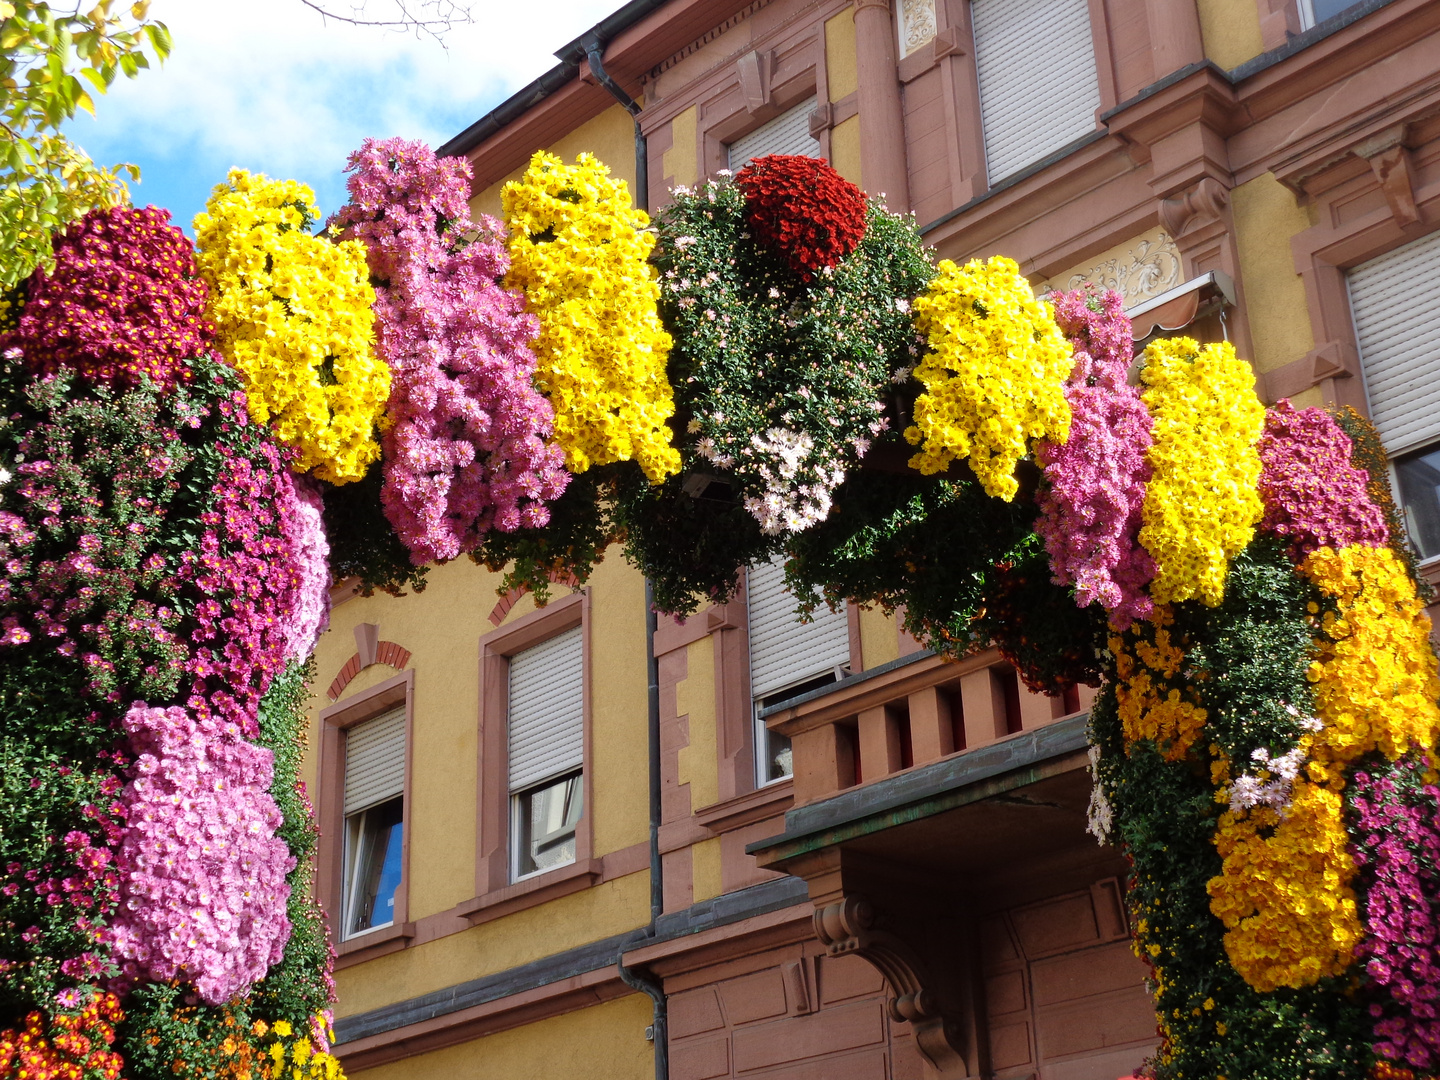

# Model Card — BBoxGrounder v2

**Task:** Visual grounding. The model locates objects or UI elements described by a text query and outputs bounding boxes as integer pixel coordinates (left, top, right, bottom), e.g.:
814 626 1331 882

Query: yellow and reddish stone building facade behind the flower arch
310 0 1440 1080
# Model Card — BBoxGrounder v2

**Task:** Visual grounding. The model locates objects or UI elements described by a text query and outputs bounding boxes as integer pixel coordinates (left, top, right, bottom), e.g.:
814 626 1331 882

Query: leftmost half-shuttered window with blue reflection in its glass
341 707 405 937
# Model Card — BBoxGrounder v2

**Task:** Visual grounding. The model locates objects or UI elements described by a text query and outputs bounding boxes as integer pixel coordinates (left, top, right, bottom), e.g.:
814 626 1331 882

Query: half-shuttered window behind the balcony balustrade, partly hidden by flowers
746 559 850 785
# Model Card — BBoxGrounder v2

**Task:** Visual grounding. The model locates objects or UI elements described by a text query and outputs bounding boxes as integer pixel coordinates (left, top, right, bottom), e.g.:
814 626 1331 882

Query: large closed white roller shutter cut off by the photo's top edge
971 0 1100 183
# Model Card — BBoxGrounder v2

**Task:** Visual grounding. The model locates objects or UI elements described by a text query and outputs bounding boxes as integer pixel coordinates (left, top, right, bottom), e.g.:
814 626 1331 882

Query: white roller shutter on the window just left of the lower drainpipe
508 626 585 792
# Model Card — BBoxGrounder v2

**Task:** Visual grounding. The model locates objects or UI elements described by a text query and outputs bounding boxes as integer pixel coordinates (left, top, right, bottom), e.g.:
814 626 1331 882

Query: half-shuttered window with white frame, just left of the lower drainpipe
507 626 585 880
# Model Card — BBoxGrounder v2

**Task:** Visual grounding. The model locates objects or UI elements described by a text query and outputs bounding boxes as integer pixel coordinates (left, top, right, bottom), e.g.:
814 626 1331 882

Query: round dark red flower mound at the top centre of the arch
734 154 867 281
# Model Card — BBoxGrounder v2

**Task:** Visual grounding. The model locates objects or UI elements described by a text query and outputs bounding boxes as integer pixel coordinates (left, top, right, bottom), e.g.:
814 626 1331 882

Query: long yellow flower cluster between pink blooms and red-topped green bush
501 151 680 482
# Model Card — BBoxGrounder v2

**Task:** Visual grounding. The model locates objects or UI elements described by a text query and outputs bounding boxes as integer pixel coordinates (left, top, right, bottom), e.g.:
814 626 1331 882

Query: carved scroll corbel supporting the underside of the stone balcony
814 894 971 1080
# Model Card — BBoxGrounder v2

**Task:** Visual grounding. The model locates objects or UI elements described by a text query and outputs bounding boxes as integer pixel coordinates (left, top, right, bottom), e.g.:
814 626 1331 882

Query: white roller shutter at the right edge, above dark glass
1349 233 1440 454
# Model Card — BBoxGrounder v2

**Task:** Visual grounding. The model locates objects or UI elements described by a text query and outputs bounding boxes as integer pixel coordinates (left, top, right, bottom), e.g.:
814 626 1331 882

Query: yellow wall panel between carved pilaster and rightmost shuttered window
1230 173 1315 372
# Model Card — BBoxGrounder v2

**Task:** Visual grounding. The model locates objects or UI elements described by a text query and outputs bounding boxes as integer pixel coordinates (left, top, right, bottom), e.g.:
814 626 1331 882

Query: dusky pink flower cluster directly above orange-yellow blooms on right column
1259 400 1390 560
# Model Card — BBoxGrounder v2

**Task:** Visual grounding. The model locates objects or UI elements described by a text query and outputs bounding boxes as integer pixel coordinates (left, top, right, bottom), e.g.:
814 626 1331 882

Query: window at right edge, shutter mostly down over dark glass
1348 233 1440 559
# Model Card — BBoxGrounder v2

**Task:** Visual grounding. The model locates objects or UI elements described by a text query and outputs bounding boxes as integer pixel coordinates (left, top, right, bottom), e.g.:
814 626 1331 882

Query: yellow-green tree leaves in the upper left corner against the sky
0 0 170 288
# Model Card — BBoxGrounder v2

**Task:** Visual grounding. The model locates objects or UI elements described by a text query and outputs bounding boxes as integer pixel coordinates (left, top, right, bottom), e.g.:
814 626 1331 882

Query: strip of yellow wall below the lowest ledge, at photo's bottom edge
350 994 655 1080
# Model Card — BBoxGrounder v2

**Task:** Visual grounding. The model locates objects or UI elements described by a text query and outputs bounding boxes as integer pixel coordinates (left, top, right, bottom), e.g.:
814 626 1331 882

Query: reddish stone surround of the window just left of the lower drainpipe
455 589 603 926
